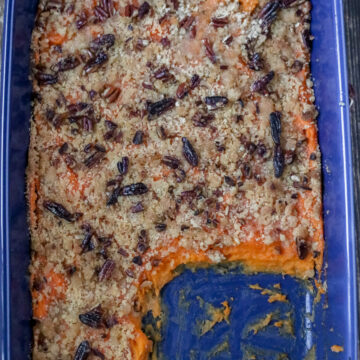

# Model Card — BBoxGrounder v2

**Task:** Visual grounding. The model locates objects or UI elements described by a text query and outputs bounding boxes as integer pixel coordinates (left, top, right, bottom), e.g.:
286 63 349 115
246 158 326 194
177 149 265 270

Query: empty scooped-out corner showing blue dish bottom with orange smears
143 264 325 360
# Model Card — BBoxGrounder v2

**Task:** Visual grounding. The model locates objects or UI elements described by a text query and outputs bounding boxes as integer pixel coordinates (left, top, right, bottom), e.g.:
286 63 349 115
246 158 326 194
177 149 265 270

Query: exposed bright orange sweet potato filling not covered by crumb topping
29 0 322 360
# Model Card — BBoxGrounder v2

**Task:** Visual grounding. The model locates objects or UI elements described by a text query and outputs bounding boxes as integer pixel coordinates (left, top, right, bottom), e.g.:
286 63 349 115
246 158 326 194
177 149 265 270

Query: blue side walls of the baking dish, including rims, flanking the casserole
0 1 357 359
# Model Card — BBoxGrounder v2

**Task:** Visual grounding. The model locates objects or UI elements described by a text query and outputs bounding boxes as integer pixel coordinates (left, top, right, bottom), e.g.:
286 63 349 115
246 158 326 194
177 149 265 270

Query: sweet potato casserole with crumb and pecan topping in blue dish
27 0 323 360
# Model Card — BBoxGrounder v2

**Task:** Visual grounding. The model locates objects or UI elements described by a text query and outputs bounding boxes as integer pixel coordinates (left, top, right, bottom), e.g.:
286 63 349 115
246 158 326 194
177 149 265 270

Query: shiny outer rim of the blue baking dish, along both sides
0 0 358 360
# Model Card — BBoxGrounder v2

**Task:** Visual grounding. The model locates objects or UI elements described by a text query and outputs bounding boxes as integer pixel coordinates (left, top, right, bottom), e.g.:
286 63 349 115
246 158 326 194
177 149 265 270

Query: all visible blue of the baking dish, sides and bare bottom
0 0 359 360
